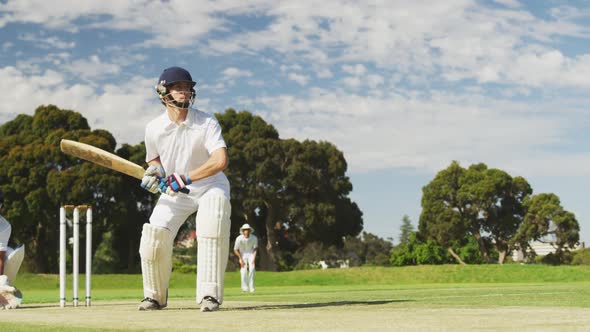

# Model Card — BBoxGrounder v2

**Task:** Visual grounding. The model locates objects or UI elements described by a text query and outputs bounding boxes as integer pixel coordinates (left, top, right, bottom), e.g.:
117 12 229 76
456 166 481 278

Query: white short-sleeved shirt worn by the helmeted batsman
145 109 229 188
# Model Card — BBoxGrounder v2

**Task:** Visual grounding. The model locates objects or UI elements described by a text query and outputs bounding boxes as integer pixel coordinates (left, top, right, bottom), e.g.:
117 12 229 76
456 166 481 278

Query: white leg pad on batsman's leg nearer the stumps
139 224 172 306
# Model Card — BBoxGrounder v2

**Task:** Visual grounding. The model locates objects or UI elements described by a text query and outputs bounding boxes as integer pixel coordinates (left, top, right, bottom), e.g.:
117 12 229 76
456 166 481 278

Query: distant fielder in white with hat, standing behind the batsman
234 224 258 292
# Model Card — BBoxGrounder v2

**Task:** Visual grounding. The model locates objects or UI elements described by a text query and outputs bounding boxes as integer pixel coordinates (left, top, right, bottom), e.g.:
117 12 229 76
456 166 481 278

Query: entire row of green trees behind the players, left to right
0 105 579 273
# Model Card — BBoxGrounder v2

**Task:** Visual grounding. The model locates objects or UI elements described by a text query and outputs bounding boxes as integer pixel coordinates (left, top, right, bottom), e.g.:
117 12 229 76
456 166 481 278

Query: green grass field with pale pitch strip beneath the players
0 265 590 331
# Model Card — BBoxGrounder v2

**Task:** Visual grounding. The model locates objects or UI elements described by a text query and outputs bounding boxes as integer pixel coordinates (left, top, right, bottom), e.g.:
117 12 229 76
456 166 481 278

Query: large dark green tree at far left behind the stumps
0 105 126 272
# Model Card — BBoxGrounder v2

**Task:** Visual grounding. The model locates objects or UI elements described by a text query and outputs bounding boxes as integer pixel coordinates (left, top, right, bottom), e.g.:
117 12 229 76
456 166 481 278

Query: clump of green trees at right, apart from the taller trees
391 162 580 265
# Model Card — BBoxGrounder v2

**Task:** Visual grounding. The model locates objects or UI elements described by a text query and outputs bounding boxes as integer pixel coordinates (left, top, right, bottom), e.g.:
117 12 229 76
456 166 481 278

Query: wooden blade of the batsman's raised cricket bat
59 139 144 180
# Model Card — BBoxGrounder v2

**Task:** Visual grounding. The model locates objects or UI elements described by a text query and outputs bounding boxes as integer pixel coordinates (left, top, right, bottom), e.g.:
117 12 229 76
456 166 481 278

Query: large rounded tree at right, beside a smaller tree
419 162 532 263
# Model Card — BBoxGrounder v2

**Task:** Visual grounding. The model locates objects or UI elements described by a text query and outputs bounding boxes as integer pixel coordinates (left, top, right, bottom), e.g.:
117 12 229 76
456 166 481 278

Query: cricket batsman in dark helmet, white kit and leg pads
139 67 231 311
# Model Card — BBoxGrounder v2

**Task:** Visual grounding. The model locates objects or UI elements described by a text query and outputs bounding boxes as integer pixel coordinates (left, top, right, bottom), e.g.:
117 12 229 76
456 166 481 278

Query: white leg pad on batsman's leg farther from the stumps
197 195 231 304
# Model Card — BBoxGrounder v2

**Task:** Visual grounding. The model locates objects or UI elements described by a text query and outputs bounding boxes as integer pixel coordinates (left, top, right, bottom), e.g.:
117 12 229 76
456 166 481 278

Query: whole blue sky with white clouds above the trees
0 0 590 243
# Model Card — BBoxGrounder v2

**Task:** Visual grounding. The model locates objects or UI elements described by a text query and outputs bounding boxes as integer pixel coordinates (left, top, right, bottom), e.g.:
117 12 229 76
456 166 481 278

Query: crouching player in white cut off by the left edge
0 190 25 309
